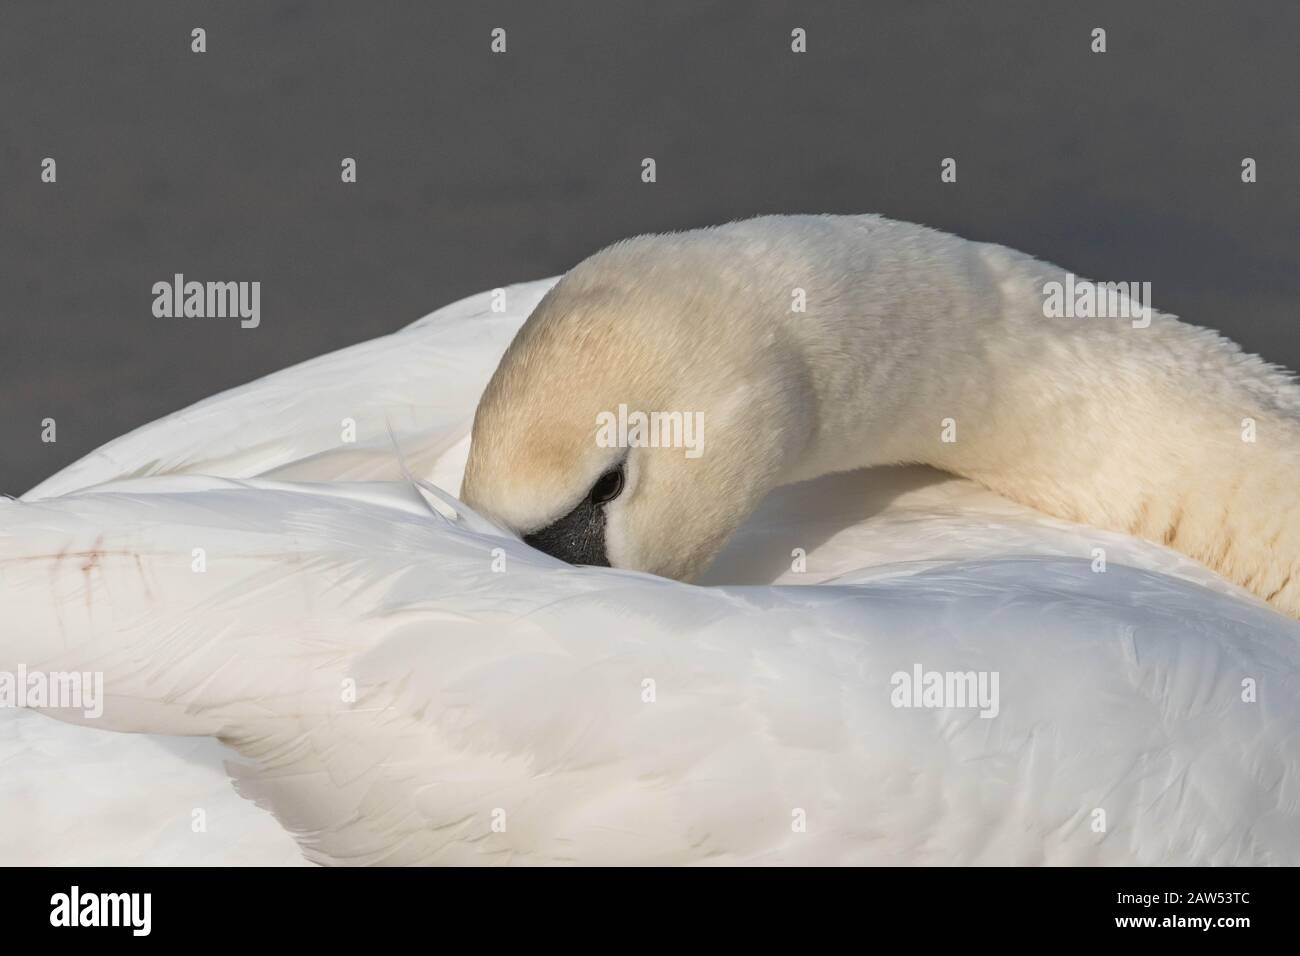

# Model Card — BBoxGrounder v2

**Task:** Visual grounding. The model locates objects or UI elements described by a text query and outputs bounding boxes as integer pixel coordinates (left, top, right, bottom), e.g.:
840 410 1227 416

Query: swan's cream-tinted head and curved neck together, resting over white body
464 216 1300 617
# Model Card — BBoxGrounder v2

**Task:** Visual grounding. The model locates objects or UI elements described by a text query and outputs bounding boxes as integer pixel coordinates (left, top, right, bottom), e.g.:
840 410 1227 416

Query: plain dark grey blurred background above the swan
0 0 1300 494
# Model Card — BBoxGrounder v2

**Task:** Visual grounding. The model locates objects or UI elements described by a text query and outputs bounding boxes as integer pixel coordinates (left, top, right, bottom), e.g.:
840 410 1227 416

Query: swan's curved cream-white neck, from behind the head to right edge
728 216 1300 617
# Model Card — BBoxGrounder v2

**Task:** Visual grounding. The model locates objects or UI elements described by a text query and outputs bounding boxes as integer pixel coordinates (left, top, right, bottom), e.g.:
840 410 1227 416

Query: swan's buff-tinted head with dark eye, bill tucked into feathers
462 233 809 580
